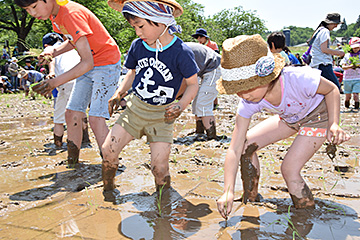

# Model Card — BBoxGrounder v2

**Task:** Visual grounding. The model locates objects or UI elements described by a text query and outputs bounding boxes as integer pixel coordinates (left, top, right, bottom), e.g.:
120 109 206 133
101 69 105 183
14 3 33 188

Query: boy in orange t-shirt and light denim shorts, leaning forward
14 0 121 167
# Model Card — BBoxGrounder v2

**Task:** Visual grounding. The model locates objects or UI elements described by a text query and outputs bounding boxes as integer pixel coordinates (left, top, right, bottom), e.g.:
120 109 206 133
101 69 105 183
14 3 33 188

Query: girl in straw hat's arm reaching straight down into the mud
217 114 250 219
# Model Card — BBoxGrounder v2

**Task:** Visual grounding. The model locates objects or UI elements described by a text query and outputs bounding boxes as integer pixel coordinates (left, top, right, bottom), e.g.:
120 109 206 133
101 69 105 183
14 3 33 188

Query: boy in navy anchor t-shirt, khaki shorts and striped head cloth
102 0 199 204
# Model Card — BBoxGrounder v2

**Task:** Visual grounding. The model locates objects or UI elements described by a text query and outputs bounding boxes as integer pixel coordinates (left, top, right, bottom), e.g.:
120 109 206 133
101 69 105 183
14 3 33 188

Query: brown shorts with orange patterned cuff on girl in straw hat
282 99 329 137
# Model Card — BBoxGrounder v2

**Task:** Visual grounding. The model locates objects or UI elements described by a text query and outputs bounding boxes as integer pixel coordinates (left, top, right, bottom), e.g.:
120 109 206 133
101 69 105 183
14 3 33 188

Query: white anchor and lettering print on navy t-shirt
135 58 174 104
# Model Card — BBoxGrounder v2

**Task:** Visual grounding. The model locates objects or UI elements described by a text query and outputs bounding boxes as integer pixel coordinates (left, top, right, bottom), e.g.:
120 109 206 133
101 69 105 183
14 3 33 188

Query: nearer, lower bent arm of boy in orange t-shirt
33 36 94 95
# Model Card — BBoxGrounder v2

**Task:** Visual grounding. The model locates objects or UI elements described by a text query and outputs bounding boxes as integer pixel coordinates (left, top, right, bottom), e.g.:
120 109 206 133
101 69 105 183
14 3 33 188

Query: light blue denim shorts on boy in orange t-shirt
66 61 121 119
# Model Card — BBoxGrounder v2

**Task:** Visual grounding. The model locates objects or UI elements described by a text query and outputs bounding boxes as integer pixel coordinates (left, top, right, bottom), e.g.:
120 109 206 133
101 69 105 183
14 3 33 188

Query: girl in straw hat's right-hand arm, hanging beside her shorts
316 77 350 144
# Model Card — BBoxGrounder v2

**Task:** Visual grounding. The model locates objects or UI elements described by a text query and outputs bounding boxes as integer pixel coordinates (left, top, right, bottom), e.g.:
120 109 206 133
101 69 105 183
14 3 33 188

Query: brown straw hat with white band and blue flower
216 34 285 94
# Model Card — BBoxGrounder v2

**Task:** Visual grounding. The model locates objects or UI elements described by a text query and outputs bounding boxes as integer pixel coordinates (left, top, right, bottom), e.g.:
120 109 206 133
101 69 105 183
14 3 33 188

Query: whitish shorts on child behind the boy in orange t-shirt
54 80 75 124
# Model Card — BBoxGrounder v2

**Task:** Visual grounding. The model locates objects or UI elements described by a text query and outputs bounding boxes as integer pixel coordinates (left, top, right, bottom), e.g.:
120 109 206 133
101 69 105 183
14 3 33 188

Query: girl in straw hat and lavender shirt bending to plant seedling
217 34 350 218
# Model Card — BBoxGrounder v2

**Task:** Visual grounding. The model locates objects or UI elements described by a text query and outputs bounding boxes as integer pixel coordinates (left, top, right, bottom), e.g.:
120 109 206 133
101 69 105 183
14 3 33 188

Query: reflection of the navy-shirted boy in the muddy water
118 188 212 240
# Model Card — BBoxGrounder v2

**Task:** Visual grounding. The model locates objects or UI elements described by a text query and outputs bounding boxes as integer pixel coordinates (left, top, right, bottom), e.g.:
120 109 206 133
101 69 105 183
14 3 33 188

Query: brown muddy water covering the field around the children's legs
0 94 360 240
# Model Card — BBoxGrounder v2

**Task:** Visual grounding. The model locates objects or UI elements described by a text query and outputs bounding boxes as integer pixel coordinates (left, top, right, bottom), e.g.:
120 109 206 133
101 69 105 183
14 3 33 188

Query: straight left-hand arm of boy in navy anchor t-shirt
108 69 135 116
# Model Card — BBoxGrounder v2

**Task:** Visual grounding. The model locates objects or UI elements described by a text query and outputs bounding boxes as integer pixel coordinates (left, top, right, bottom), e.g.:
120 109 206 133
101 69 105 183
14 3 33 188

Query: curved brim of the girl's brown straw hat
216 53 285 94
